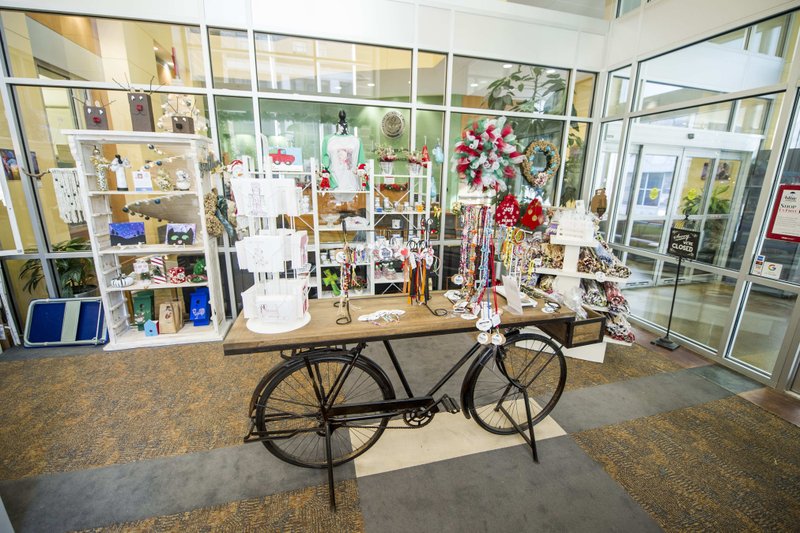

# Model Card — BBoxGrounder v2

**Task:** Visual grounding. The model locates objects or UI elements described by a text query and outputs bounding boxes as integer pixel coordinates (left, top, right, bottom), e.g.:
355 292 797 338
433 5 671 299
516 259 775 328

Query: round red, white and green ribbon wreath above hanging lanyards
454 117 525 191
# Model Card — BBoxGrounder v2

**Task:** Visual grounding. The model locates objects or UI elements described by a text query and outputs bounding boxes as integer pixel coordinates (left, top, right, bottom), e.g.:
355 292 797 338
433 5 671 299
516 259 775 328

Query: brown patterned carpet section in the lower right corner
573 396 800 531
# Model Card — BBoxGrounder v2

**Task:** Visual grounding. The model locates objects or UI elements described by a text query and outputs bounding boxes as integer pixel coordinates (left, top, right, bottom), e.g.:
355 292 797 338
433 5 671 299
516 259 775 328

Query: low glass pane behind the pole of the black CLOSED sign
625 253 736 350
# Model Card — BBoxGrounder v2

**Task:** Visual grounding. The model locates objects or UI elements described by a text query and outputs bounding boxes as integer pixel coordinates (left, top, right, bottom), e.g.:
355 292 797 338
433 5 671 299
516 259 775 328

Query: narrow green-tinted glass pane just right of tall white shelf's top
214 96 256 165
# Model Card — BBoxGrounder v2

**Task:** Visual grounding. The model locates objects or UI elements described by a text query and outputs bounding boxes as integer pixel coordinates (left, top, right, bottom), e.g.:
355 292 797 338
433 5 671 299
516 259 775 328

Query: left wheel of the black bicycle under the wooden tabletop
255 353 395 468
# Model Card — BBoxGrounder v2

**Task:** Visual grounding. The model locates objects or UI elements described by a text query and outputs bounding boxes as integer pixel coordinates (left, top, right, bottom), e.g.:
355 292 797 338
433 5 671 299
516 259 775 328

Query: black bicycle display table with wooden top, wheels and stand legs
223 293 575 509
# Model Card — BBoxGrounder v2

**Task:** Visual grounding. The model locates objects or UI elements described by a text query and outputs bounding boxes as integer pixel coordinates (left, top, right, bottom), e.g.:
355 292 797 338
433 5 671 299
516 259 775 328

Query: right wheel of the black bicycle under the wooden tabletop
466 333 567 435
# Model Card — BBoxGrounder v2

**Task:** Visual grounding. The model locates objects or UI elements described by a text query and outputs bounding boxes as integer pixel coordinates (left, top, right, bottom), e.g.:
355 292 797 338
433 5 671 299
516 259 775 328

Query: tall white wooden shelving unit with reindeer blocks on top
63 130 230 350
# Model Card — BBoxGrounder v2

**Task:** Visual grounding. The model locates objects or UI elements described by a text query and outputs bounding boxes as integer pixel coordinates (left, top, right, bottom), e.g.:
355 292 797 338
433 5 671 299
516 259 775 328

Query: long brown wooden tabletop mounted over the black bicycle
222 292 575 355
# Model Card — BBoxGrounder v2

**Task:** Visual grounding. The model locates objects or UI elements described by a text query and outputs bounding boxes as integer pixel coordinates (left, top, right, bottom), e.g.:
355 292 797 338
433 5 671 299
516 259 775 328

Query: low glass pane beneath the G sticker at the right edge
729 284 797 374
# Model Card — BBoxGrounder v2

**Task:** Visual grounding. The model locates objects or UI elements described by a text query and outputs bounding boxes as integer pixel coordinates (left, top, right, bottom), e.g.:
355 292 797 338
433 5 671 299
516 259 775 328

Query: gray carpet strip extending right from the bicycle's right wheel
551 369 731 433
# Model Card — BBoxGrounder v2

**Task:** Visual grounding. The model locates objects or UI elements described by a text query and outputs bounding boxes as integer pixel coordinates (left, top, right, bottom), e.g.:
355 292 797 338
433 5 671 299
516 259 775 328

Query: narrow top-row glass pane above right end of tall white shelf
208 28 250 91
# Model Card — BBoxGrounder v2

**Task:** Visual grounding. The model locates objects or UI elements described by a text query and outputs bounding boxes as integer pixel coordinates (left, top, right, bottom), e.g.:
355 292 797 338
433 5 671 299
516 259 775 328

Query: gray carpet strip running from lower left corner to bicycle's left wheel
0 443 355 532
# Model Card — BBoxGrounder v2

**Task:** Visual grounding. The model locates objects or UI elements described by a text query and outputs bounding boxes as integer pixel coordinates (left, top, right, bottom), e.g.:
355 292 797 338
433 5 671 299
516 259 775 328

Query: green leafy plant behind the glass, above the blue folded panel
20 237 97 298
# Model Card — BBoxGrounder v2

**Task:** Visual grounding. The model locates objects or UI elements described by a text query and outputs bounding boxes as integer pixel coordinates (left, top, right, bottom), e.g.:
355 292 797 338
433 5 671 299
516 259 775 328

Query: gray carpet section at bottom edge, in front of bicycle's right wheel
358 437 660 533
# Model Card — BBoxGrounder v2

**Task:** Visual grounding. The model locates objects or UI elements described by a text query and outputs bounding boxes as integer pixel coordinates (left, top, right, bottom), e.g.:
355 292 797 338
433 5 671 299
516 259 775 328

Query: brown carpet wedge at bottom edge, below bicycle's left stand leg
76 479 364 533
